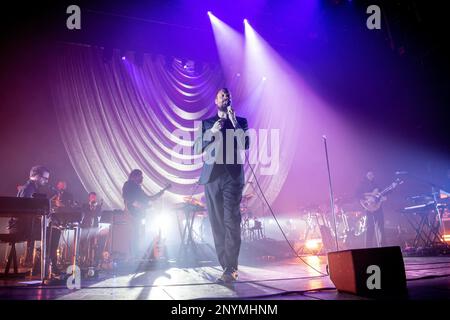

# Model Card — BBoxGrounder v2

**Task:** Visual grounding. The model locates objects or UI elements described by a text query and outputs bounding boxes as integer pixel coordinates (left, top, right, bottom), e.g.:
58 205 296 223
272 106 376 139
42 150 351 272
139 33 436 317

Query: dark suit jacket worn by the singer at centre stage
194 115 250 185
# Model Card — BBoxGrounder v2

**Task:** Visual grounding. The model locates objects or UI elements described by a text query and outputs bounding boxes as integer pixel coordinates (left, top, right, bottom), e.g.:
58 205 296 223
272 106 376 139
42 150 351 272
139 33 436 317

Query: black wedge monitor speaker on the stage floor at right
328 247 407 298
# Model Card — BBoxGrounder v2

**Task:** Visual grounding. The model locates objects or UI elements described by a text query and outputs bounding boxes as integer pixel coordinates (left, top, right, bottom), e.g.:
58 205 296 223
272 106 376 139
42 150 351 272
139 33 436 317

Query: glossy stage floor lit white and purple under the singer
0 256 450 300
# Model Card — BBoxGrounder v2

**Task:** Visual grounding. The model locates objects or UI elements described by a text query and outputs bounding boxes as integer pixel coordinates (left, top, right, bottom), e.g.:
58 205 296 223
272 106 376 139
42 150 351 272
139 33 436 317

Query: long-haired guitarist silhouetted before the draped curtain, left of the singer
122 169 165 258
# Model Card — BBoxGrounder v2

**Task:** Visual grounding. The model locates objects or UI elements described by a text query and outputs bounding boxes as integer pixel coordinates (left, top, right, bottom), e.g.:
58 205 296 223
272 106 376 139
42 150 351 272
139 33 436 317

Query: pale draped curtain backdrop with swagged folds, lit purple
52 45 295 208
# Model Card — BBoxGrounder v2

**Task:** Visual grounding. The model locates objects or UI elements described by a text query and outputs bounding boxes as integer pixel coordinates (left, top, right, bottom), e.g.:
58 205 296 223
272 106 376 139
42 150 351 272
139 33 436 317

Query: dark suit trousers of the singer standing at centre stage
205 169 244 271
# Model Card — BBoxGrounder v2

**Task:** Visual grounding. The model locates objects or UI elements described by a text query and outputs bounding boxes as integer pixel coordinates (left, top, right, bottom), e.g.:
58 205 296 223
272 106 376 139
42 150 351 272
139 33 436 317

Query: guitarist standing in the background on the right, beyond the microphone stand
357 171 396 248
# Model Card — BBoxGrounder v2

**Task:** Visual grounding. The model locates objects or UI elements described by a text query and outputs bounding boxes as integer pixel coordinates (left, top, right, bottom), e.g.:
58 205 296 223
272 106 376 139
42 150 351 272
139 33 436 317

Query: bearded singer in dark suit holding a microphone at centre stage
194 88 249 283
